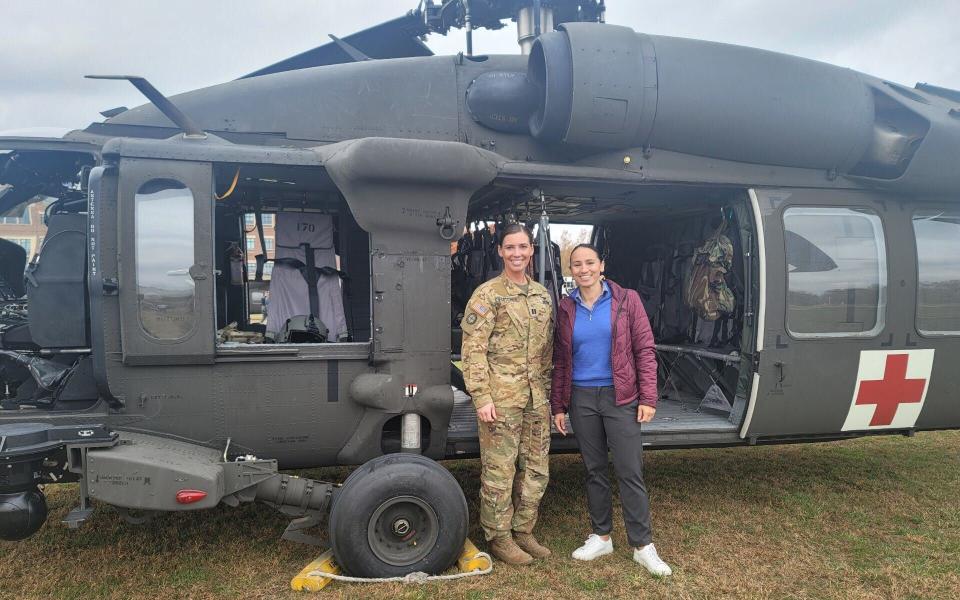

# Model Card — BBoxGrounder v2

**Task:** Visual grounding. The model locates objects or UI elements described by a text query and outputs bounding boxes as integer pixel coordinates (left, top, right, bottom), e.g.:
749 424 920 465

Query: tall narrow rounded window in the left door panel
134 179 197 340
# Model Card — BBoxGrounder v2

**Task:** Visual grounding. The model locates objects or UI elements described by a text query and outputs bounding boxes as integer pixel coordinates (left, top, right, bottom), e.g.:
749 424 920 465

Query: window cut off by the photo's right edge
913 210 960 335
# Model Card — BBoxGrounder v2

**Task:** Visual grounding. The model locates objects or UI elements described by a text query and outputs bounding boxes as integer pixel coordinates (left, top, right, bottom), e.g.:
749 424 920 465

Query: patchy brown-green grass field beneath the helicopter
0 432 960 600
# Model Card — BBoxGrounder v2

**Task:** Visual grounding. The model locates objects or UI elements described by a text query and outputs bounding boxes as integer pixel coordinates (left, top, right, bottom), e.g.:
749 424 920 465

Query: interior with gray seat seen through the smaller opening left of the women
208 165 371 353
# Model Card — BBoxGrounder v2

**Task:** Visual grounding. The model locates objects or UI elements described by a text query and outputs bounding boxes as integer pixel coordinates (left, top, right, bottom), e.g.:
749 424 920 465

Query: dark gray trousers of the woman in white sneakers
570 386 651 547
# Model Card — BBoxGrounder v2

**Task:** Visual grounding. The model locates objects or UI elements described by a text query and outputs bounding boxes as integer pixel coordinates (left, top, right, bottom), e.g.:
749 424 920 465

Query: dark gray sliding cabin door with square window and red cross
741 185 933 439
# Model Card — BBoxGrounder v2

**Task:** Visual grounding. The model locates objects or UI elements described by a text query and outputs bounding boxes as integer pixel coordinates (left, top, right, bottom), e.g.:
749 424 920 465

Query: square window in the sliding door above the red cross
783 207 887 338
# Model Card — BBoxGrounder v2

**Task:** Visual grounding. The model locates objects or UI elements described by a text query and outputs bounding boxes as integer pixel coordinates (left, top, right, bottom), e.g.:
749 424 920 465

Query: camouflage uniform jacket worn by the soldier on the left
461 274 553 408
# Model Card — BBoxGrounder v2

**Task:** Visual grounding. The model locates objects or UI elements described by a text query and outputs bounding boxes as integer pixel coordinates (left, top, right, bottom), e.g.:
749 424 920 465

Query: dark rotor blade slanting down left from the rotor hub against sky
241 12 433 79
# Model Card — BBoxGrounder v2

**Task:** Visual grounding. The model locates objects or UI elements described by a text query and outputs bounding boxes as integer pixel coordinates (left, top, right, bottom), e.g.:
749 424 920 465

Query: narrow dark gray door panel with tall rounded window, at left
118 158 215 365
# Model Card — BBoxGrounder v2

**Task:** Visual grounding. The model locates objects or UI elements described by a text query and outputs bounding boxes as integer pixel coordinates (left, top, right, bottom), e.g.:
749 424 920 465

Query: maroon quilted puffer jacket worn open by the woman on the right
550 280 657 415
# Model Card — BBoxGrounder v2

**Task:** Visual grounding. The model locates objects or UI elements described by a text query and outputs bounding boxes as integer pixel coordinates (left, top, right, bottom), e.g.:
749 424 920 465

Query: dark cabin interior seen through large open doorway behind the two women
451 183 757 441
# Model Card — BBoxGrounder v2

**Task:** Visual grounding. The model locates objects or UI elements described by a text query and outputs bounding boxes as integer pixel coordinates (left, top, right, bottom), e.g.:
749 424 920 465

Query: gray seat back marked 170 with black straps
267 212 348 341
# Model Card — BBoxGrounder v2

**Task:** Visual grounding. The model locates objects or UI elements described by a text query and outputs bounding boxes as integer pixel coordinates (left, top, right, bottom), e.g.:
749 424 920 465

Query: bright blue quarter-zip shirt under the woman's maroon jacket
570 281 613 387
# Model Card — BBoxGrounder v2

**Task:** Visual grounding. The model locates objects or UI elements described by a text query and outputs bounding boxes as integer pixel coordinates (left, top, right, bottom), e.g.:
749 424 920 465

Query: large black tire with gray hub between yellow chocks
329 454 469 577
